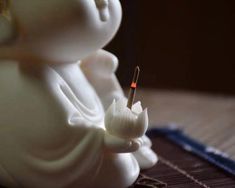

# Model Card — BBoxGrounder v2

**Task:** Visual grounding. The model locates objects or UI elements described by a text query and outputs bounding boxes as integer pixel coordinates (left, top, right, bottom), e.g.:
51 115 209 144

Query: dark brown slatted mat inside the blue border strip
140 137 235 188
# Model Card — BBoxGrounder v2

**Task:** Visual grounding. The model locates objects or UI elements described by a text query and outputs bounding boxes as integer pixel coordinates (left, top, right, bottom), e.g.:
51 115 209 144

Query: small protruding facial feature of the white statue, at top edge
95 0 110 22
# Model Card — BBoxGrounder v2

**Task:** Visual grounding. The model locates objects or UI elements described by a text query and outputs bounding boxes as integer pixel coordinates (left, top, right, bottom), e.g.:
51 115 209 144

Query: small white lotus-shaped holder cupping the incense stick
105 99 148 139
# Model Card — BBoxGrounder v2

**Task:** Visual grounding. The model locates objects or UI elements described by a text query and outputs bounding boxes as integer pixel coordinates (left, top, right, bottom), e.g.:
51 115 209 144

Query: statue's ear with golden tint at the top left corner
0 0 16 45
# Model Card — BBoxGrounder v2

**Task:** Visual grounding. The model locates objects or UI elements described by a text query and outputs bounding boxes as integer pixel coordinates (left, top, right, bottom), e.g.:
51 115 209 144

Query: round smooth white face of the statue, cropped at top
12 0 121 62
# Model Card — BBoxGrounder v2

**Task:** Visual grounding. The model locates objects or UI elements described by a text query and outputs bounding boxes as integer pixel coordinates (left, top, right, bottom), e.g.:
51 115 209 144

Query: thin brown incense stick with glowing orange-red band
127 66 140 109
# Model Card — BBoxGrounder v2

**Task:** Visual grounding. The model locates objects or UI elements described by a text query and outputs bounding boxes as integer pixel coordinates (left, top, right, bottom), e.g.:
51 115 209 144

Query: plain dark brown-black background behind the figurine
106 0 235 95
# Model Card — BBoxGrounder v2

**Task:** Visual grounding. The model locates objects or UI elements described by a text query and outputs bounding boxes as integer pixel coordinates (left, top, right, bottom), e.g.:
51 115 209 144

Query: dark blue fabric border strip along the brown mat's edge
147 128 235 176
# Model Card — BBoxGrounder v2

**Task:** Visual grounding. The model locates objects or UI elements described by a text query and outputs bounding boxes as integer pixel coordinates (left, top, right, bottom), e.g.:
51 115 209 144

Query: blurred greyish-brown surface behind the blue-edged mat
136 89 235 160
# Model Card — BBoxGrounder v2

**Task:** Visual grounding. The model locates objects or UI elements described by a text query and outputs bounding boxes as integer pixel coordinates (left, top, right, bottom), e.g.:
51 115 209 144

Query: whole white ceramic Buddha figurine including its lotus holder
0 0 157 188
